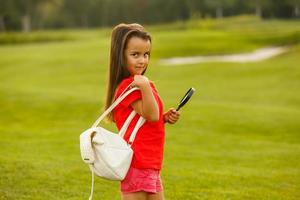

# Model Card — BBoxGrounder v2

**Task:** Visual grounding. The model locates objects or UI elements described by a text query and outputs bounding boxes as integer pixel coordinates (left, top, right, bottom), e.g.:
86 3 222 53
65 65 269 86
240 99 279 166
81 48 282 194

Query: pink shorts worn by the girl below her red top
121 167 163 194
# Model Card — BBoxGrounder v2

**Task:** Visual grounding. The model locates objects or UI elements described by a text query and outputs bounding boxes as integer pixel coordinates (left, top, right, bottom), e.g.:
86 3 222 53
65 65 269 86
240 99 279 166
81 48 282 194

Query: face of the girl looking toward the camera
124 37 151 76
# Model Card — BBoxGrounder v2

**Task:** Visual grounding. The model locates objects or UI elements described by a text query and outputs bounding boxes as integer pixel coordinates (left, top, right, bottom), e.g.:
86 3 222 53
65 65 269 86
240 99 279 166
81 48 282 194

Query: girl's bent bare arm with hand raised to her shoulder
131 75 159 122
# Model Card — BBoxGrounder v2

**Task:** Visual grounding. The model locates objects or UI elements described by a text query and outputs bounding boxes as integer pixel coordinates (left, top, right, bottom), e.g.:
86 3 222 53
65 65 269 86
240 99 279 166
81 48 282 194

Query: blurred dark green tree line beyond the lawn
0 0 300 32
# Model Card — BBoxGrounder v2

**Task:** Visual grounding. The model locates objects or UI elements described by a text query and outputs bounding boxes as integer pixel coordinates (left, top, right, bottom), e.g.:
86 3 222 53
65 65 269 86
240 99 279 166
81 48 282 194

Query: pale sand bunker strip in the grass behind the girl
159 47 288 65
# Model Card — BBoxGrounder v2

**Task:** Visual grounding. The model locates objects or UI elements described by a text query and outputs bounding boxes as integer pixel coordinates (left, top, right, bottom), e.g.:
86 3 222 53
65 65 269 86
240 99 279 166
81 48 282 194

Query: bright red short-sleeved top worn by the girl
113 77 165 170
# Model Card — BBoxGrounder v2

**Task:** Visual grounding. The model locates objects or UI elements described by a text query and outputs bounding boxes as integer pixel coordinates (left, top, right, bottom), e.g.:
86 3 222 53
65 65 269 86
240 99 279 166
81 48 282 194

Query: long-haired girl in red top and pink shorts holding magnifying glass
106 24 180 200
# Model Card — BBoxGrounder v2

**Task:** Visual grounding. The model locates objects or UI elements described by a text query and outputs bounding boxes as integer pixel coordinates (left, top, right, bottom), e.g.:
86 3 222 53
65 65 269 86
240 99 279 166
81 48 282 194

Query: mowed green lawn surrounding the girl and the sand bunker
0 17 300 200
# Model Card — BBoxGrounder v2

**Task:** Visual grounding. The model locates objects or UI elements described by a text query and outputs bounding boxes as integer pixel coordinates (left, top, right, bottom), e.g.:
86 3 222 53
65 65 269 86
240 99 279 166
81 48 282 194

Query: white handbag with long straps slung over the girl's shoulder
80 86 145 199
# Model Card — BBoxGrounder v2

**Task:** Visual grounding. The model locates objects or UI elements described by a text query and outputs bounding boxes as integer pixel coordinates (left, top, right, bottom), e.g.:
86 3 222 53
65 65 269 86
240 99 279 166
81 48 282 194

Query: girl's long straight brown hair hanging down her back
105 24 151 121
